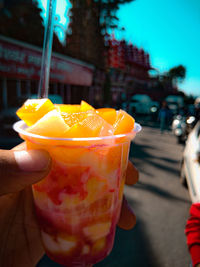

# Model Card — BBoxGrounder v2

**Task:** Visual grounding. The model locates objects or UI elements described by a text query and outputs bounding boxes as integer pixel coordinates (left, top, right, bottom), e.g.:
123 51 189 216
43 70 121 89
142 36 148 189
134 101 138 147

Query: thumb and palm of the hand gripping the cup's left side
0 143 51 267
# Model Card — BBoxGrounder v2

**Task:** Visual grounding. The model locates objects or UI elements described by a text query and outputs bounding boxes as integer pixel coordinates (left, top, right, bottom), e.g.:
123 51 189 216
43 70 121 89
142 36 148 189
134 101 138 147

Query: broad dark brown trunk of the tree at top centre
66 0 104 67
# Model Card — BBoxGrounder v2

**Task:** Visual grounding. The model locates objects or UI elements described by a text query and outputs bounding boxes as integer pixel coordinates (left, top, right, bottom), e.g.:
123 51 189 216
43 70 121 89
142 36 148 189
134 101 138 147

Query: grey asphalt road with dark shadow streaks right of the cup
37 127 191 267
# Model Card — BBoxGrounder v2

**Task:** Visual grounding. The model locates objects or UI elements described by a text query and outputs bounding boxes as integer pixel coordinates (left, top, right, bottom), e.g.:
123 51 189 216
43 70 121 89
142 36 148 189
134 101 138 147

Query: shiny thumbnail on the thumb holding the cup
14 150 51 172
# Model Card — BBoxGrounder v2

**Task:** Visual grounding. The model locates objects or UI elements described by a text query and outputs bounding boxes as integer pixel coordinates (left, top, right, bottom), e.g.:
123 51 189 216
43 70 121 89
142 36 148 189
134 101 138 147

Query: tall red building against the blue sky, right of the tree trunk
106 37 152 106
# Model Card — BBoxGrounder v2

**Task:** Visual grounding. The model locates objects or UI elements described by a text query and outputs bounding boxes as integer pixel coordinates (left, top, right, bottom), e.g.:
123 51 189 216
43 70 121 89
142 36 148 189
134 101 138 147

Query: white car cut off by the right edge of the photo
181 121 200 203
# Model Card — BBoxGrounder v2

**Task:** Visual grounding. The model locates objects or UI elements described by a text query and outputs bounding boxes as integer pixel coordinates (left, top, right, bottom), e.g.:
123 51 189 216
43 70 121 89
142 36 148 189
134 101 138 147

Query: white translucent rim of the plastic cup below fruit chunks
13 120 142 141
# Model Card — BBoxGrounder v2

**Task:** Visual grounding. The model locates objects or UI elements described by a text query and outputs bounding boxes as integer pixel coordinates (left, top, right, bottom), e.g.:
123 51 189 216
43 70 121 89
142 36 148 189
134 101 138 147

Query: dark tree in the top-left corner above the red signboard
0 0 63 52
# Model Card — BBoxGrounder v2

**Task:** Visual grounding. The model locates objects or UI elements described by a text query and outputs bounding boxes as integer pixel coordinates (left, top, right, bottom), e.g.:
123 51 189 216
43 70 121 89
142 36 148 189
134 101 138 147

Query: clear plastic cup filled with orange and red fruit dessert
14 121 141 267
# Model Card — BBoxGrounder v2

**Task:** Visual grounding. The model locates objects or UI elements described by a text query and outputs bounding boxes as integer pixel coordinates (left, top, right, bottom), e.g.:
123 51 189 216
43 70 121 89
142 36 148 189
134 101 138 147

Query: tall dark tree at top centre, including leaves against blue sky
66 0 134 68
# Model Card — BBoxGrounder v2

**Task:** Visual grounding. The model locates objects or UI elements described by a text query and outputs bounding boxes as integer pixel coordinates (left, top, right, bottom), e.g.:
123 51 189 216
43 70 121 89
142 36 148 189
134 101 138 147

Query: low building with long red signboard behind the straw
0 35 94 111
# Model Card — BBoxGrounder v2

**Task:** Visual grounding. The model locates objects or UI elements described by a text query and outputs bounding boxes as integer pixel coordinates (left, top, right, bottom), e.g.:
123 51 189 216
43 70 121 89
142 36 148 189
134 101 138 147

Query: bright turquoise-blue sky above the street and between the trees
38 0 200 95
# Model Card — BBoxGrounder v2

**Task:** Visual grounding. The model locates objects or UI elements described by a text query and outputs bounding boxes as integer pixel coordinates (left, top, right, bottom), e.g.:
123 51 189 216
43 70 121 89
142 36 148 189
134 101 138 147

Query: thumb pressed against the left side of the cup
0 150 51 195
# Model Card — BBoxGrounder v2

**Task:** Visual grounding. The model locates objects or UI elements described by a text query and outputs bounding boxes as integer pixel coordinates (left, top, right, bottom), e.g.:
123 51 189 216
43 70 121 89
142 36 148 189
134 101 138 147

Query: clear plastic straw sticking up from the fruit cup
38 0 56 98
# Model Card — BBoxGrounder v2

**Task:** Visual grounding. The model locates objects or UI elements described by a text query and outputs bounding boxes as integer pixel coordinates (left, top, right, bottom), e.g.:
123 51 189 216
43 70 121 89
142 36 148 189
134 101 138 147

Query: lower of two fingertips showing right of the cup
117 197 136 230
